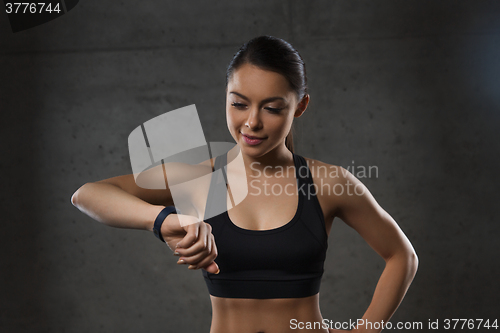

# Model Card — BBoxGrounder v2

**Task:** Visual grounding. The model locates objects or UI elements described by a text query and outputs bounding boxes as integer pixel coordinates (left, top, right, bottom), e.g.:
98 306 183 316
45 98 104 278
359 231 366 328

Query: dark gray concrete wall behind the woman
0 0 500 332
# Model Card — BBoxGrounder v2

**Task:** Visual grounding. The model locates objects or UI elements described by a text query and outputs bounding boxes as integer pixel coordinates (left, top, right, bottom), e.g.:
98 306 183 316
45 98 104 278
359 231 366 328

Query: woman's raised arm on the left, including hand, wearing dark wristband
71 166 219 273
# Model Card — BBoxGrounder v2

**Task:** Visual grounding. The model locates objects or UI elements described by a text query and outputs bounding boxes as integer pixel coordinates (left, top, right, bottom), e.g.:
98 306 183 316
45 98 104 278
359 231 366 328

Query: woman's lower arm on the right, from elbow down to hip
353 252 418 333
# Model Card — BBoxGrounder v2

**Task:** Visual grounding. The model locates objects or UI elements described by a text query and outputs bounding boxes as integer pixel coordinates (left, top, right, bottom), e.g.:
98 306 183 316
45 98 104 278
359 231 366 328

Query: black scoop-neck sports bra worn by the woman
202 154 328 299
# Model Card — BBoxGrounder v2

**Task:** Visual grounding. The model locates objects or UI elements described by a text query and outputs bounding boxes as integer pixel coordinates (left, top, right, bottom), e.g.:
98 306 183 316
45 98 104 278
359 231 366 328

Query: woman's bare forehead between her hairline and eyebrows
228 64 293 98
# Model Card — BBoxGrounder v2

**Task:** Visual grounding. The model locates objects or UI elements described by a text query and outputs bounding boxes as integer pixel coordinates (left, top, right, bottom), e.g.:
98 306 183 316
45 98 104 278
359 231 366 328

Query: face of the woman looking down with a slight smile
226 64 307 157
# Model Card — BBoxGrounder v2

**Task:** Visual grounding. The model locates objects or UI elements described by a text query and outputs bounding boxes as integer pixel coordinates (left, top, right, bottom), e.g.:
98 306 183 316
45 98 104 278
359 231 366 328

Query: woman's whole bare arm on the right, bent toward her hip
332 169 418 333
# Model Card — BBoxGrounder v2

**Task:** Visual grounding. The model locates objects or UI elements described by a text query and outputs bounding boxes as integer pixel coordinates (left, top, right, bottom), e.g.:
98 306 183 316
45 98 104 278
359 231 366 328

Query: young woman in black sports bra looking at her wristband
72 36 418 333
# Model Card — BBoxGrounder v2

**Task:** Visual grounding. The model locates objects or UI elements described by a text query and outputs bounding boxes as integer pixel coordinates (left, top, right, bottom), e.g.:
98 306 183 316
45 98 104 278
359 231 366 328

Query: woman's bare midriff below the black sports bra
210 294 328 333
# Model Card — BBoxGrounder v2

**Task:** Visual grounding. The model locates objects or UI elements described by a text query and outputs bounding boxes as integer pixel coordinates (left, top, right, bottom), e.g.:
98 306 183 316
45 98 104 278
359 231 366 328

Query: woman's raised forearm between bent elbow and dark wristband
71 182 164 230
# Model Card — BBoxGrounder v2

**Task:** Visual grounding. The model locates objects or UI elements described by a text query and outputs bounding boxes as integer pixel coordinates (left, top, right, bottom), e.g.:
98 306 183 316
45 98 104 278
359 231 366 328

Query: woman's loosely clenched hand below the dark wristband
161 214 219 274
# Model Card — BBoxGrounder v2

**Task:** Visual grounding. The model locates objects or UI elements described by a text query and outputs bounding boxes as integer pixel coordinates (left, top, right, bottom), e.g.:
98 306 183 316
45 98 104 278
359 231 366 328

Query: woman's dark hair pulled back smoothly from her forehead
226 36 307 152
